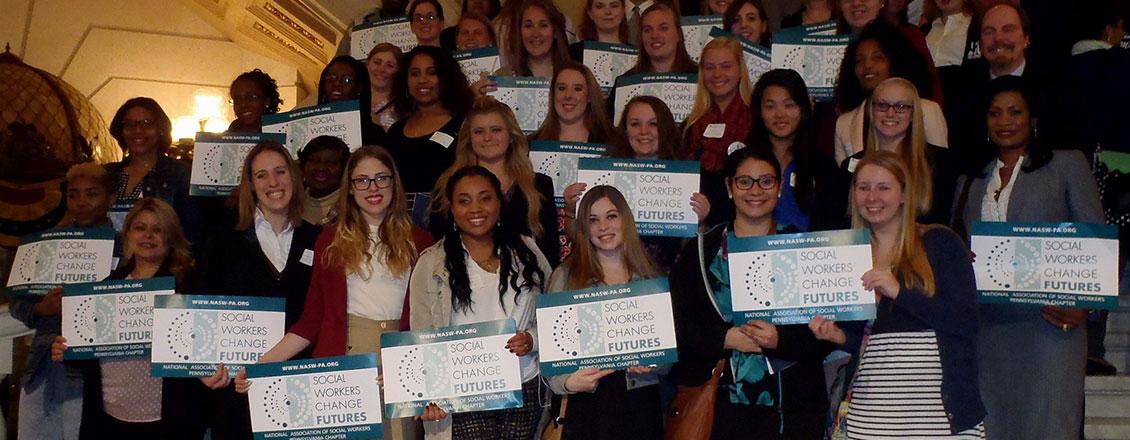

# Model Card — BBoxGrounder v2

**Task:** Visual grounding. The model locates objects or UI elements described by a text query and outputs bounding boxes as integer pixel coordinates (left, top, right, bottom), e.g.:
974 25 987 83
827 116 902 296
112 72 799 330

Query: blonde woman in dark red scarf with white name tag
683 36 754 172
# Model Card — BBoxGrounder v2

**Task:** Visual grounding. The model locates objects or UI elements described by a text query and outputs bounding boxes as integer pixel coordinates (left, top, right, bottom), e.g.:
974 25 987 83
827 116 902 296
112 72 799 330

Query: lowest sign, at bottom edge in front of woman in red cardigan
247 353 382 440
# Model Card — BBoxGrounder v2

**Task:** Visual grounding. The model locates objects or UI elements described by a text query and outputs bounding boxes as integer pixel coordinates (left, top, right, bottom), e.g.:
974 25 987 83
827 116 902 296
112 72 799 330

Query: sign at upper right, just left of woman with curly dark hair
773 32 853 101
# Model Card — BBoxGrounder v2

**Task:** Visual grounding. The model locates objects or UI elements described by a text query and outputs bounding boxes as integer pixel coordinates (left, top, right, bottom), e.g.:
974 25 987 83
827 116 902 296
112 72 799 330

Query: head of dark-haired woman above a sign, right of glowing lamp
227 69 283 132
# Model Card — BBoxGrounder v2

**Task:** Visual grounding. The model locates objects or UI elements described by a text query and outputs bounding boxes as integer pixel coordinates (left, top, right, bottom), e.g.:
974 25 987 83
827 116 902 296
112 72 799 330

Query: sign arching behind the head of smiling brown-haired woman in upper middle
612 74 698 123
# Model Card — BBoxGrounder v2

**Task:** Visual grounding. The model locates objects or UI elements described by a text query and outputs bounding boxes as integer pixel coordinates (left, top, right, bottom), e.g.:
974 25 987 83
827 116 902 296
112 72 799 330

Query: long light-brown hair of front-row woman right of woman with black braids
562 186 662 290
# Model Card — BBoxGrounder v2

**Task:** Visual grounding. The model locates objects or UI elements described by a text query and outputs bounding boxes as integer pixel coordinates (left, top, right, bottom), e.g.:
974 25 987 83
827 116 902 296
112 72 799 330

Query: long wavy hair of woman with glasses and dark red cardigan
322 145 418 275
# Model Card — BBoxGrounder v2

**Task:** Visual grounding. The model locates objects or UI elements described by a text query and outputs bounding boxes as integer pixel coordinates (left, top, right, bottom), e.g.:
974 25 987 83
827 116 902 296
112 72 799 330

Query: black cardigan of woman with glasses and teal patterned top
669 224 833 413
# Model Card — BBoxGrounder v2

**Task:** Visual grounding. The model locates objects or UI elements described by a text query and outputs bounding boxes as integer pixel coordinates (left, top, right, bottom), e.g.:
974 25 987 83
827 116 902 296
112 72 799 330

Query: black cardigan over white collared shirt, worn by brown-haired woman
199 222 322 328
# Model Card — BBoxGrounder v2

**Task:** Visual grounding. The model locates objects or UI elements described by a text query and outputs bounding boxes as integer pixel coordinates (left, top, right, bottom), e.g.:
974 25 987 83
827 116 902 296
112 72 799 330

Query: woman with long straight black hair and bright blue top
746 69 848 232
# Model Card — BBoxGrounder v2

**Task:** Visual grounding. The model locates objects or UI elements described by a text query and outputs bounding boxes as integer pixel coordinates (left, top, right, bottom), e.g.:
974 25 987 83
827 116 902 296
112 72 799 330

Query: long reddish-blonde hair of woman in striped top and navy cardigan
848 150 935 297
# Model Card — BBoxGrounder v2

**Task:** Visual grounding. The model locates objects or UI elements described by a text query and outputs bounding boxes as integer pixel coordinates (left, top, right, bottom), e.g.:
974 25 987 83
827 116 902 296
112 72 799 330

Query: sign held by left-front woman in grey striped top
62 277 176 361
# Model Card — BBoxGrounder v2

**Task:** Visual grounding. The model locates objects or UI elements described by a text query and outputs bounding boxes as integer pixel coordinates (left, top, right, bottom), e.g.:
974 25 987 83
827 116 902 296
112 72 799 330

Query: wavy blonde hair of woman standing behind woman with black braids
428 96 544 238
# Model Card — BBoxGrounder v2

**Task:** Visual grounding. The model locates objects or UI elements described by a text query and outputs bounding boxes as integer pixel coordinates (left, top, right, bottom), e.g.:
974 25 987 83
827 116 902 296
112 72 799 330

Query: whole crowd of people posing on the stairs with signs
10 0 1130 440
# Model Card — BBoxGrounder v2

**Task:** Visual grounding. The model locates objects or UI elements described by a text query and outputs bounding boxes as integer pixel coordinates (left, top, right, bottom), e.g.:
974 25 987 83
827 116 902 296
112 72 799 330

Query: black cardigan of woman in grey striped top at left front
75 260 206 440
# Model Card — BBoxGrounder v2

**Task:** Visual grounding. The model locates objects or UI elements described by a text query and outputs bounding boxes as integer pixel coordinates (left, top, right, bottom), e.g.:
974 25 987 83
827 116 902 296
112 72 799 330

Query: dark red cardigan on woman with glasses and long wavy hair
290 225 435 357
